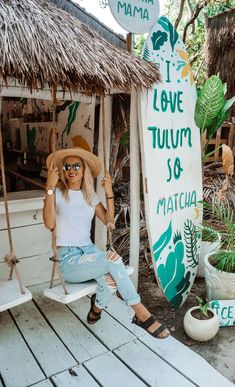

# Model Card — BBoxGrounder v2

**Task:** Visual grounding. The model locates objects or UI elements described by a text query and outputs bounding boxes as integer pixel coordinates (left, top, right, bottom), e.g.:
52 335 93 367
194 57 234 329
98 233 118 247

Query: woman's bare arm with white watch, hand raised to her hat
43 160 59 231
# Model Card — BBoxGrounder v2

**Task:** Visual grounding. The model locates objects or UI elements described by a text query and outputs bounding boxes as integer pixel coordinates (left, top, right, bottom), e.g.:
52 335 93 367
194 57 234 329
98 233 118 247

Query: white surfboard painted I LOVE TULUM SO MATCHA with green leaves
138 16 202 307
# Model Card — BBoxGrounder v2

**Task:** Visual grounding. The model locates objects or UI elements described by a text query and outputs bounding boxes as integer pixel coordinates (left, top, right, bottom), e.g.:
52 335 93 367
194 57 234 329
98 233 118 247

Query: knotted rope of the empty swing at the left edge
0 97 25 294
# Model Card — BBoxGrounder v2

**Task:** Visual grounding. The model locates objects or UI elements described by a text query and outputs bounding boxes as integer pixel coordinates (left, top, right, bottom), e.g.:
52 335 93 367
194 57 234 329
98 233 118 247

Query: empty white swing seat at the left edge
0 278 32 312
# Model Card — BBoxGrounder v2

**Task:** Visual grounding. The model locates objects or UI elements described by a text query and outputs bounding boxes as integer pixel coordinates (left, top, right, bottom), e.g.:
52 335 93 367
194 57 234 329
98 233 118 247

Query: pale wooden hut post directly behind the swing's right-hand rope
95 95 113 251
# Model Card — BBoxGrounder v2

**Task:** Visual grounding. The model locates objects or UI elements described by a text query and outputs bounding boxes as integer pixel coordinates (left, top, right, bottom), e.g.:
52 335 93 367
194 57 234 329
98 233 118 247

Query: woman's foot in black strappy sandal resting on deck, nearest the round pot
132 315 170 339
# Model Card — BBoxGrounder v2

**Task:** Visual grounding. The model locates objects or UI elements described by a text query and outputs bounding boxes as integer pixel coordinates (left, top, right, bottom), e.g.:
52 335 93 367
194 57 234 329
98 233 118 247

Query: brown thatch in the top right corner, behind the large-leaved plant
205 9 235 97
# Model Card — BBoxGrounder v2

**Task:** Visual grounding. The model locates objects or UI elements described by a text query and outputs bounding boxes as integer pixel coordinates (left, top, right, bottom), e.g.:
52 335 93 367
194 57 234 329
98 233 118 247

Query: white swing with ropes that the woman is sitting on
43 95 134 304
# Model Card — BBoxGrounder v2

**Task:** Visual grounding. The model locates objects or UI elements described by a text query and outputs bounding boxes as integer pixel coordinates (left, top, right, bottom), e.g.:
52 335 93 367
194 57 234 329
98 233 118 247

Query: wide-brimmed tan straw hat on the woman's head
46 147 102 177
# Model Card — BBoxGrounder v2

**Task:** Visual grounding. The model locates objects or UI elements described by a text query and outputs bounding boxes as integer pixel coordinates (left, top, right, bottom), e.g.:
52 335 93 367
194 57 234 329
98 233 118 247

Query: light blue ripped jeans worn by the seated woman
57 243 140 309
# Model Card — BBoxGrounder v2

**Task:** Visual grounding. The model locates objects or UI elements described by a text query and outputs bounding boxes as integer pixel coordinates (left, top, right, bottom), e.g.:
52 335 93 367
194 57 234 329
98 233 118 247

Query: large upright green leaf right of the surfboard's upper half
194 75 235 160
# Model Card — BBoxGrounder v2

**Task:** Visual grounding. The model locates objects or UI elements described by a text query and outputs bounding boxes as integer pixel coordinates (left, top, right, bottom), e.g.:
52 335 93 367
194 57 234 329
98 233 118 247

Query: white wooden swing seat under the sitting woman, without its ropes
43 266 134 304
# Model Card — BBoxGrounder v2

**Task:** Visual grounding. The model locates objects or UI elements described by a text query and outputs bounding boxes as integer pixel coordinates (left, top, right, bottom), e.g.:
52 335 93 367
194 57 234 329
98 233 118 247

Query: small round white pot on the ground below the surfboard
184 306 219 341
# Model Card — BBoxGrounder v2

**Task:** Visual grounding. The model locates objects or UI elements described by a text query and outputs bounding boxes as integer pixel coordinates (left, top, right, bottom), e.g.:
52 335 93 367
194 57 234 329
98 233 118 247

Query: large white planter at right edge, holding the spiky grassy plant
205 254 235 301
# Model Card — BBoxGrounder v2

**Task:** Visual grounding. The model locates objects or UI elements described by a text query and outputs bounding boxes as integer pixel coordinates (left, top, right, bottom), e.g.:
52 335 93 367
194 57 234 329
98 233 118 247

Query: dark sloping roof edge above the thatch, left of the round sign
50 0 126 48
